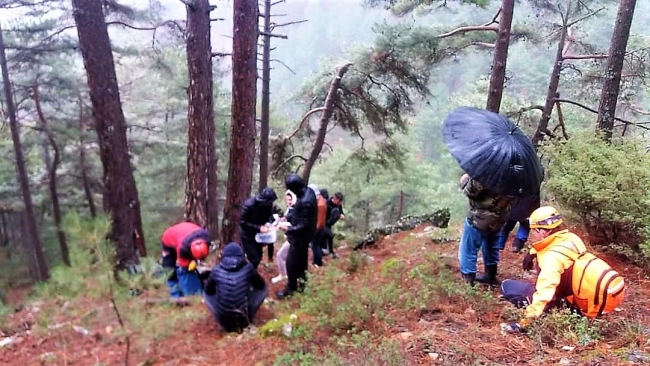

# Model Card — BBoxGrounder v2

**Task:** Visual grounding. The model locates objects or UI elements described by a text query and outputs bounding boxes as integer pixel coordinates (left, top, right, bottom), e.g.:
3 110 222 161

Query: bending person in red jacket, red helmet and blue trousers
161 222 210 297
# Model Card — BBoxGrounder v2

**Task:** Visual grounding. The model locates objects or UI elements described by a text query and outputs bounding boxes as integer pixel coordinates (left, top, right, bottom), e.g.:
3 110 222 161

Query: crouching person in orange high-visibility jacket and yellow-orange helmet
501 206 625 329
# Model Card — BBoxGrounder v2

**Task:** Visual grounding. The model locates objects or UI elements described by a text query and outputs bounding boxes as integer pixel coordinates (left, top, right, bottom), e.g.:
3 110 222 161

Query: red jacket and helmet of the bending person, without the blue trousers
160 222 210 267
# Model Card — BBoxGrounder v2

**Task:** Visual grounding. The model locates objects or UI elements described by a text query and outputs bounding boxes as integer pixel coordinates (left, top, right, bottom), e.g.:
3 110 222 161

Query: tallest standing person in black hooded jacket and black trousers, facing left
276 174 317 299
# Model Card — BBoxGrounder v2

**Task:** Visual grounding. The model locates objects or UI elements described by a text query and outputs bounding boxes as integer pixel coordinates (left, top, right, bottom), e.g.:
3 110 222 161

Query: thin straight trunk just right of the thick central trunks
259 0 271 192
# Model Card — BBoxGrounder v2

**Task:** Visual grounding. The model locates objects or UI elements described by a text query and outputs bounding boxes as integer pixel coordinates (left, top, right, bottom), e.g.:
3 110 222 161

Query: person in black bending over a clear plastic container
239 187 278 269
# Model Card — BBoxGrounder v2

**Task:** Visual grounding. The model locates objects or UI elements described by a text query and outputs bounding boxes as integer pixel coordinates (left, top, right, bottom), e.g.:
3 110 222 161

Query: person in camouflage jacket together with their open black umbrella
442 107 543 285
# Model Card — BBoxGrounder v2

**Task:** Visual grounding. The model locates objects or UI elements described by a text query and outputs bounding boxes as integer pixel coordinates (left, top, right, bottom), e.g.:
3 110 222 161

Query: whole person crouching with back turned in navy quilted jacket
203 243 268 332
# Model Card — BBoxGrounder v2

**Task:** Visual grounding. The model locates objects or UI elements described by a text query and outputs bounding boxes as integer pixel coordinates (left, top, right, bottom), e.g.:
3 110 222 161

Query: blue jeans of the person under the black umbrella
458 219 501 274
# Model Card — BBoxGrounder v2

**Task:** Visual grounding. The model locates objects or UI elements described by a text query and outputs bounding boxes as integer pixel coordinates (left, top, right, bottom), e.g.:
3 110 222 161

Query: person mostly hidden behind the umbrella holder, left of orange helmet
497 195 540 253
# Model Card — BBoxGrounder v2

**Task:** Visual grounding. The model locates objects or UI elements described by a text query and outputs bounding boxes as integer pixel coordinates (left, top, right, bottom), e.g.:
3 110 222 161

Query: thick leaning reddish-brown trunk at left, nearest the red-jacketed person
72 0 144 270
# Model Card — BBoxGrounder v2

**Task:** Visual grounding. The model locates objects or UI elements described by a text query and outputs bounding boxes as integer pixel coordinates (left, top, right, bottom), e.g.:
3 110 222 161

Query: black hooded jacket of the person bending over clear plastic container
239 187 278 239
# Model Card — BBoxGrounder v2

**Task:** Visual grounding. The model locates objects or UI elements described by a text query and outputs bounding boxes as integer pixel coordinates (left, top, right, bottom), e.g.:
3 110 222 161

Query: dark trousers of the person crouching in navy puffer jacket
203 285 269 332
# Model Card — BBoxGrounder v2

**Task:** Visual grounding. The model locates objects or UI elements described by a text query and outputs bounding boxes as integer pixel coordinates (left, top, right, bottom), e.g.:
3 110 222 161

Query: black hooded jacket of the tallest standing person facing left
285 174 317 243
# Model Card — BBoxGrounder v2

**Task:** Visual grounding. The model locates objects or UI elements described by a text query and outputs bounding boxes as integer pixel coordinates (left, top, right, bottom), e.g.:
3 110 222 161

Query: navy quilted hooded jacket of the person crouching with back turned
204 243 266 315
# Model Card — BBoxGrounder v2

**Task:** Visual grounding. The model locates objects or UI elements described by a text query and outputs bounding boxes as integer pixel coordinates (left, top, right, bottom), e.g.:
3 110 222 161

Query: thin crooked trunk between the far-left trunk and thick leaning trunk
32 83 70 266
